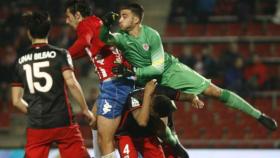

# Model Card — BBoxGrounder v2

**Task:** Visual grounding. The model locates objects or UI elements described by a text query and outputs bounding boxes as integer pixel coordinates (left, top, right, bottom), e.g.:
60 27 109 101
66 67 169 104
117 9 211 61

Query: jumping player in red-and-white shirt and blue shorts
65 1 134 157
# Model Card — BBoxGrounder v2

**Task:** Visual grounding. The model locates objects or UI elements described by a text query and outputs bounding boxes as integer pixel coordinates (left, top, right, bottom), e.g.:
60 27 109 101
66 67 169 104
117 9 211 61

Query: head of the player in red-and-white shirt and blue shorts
65 0 91 28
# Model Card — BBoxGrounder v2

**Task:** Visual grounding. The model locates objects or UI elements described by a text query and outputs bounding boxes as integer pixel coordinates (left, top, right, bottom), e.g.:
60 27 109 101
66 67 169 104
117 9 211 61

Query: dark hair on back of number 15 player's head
23 11 51 38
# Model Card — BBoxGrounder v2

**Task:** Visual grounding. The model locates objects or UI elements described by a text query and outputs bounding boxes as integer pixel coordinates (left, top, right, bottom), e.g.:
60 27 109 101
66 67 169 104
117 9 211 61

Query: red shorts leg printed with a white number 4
117 136 138 158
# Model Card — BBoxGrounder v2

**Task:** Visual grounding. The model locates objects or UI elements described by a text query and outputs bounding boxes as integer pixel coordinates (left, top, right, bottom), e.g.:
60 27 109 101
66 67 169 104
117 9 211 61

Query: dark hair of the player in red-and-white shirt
65 0 92 17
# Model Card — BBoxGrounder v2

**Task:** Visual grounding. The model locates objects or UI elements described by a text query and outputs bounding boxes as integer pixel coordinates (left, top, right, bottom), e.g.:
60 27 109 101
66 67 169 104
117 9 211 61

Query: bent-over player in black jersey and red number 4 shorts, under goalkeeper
116 80 204 158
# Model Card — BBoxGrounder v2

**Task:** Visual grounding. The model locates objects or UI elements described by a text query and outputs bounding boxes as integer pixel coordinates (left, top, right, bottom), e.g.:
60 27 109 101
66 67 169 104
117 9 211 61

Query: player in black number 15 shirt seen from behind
12 12 95 158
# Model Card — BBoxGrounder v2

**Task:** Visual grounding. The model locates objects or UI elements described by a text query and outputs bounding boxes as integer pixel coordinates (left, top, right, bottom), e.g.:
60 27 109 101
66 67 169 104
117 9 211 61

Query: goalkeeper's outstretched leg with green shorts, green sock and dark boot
161 63 277 130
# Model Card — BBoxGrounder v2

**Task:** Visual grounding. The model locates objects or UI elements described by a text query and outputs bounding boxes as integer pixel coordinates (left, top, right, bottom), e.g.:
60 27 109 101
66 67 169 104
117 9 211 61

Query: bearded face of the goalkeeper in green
119 9 139 31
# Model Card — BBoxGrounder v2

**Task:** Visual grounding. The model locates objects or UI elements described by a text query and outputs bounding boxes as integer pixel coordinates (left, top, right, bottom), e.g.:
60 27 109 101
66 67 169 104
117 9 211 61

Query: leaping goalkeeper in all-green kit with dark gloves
100 3 277 130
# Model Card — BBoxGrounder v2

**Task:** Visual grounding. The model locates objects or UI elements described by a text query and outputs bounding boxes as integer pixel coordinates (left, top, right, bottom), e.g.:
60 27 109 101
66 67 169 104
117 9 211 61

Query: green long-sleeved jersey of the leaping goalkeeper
106 25 178 84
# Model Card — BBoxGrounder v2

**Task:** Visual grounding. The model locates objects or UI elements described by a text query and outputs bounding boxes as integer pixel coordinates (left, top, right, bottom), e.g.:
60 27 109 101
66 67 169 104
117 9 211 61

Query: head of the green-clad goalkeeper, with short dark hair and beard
119 3 144 31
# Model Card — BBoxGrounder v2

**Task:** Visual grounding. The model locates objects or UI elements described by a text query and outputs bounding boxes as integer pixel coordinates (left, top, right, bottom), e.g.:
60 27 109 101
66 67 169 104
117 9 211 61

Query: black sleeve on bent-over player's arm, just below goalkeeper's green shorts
155 85 180 100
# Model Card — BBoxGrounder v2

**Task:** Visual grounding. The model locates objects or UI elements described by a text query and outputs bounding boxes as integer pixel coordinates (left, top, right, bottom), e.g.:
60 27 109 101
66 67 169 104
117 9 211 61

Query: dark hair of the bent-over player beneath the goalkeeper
153 95 177 117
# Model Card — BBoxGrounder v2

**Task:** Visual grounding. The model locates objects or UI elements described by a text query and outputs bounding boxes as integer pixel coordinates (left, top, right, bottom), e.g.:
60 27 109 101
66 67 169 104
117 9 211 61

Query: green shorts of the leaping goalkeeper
160 62 211 95
